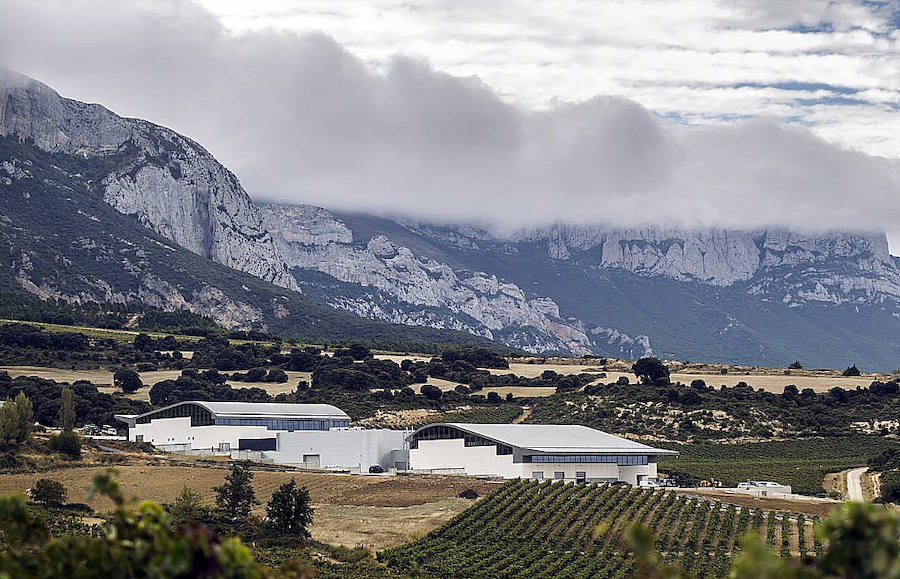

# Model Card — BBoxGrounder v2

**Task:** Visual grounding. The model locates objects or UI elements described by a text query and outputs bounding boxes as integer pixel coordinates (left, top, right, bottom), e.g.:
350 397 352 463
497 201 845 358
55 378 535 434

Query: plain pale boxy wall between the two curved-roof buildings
263 429 409 473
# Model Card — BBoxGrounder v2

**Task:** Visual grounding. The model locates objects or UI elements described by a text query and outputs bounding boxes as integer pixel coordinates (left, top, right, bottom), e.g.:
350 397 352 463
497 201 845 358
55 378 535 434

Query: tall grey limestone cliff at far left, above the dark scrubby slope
0 70 296 289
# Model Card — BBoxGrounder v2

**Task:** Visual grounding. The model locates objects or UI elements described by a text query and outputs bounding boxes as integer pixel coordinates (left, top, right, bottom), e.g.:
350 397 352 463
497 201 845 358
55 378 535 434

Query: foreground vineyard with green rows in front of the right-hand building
379 481 822 579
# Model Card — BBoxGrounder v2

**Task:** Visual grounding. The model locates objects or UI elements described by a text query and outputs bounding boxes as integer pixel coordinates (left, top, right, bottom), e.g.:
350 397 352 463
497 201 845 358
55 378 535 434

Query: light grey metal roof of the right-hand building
413 422 678 456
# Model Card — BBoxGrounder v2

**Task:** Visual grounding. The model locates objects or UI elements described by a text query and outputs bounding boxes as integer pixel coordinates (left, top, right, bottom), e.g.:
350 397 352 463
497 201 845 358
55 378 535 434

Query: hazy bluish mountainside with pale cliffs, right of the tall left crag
261 205 900 370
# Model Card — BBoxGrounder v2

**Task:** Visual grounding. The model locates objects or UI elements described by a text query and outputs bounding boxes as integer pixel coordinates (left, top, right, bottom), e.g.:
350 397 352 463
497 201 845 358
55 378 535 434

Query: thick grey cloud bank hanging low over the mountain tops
0 0 900 246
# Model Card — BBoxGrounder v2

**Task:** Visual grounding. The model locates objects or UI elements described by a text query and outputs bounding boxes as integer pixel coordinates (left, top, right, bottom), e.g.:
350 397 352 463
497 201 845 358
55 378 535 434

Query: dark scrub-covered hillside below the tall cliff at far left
0 137 506 343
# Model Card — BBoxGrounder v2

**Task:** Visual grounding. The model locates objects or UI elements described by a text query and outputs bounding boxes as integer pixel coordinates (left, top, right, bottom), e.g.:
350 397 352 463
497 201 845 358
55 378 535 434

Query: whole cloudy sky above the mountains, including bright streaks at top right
0 0 900 245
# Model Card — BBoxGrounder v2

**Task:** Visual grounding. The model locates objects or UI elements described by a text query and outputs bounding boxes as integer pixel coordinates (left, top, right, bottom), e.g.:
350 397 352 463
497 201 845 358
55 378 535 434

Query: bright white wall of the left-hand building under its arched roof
128 416 276 450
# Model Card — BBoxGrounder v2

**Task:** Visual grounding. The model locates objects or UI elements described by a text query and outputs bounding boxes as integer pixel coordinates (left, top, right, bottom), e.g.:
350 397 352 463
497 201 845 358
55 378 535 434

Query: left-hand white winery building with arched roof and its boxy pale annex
116 401 409 472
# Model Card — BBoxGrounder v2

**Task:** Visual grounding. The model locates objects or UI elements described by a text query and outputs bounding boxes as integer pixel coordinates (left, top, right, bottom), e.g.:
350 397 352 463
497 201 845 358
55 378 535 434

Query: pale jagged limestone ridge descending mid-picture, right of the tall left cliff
261 205 591 354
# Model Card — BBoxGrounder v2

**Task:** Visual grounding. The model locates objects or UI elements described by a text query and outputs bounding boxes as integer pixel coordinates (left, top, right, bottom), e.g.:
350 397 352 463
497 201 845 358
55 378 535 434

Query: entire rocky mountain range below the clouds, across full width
0 72 900 370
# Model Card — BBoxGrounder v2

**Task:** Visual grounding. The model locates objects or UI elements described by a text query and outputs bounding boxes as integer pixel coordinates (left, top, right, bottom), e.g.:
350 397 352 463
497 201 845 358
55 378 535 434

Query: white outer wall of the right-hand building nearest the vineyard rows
409 438 656 485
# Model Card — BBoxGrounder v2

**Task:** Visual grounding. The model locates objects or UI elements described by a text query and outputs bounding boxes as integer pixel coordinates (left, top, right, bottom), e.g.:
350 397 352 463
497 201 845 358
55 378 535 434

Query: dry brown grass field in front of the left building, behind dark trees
0 463 497 549
